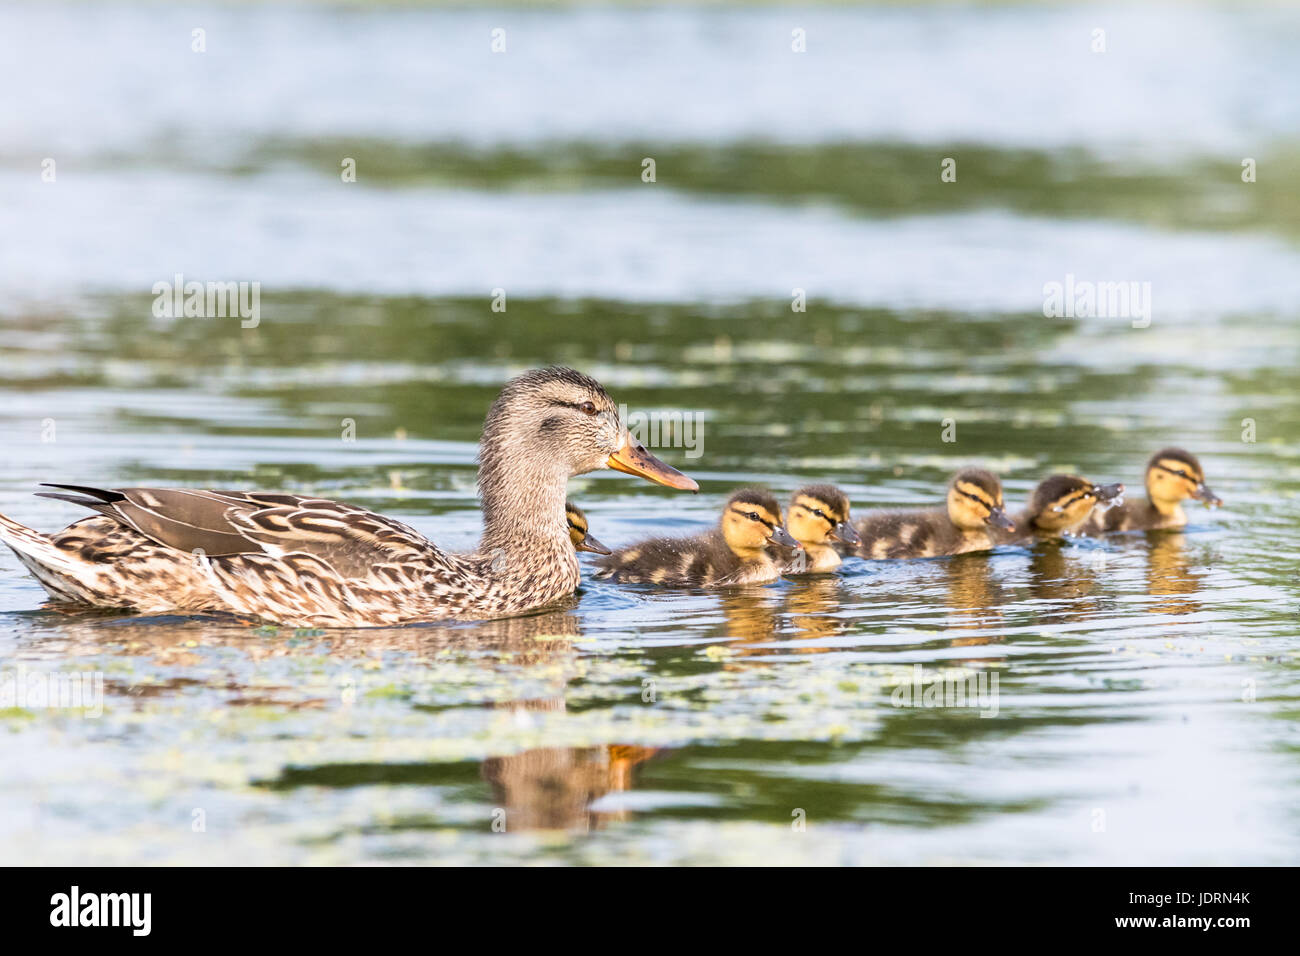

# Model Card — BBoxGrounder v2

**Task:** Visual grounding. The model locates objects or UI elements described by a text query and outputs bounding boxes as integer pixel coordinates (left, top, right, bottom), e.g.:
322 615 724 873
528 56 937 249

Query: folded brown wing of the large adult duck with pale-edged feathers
40 485 441 578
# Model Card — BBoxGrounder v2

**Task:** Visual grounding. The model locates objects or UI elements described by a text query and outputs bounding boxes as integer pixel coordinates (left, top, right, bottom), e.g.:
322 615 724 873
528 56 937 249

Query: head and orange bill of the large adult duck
478 367 699 492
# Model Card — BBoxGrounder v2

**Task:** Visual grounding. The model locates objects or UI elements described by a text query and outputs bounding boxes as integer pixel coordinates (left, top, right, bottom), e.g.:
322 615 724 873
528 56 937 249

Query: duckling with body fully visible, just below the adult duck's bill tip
597 488 800 588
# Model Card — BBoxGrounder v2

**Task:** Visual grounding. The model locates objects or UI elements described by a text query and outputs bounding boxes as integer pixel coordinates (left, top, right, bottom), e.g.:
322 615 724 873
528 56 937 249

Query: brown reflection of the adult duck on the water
23 601 660 831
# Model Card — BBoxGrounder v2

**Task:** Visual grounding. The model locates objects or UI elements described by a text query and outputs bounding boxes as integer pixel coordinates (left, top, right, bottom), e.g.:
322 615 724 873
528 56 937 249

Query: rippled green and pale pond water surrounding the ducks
0 4 1300 864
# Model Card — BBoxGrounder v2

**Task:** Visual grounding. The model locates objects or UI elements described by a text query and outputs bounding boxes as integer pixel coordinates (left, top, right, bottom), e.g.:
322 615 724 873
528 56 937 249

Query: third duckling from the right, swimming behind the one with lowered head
858 468 1015 561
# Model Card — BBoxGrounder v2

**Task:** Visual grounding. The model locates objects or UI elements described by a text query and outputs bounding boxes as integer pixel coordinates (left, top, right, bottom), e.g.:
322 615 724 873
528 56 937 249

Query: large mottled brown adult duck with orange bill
0 368 697 627
